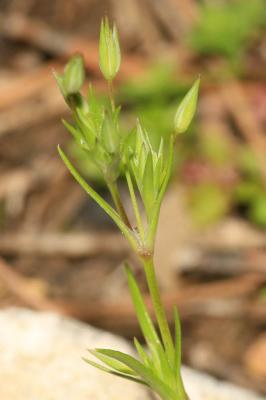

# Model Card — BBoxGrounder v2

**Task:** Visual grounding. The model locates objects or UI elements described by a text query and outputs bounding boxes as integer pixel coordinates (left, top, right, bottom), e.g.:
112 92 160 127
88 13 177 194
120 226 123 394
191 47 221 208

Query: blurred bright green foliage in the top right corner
189 0 266 59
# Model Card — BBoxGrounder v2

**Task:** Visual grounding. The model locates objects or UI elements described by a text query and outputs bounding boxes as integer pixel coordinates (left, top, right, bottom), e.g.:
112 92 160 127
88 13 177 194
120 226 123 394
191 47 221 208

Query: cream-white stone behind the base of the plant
0 308 262 400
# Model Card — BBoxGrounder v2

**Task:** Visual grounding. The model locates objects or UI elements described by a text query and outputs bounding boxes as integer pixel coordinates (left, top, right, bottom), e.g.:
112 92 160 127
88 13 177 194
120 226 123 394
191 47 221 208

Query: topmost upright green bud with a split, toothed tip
99 18 121 81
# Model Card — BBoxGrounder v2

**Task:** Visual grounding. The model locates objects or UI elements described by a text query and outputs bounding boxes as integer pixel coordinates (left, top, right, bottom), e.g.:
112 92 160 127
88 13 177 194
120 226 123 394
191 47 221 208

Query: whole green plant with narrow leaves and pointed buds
55 19 199 400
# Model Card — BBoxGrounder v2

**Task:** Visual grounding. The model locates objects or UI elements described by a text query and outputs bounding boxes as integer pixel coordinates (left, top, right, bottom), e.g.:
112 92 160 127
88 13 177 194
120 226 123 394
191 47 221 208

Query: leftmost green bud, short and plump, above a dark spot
63 56 85 96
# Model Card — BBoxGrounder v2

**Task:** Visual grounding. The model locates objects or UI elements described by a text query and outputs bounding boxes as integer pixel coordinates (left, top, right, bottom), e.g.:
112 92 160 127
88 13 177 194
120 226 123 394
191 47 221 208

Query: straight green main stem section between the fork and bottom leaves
141 257 174 365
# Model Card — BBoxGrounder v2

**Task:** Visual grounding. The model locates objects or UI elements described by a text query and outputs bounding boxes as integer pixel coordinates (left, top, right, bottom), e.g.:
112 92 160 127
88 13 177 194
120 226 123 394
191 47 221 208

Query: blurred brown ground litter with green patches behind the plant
0 0 266 394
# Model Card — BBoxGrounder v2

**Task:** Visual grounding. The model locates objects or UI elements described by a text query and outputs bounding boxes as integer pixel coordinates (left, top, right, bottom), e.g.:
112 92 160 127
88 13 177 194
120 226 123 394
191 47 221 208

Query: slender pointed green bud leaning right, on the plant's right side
174 79 200 134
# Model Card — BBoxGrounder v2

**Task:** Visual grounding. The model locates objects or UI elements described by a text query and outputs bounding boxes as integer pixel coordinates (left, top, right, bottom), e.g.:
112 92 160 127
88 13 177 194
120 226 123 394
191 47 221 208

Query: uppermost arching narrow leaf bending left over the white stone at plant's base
97 349 176 400
